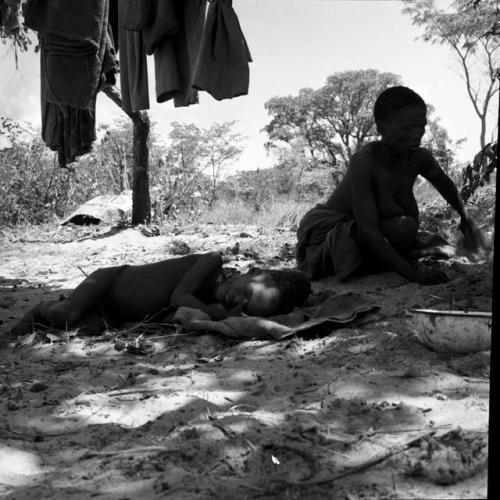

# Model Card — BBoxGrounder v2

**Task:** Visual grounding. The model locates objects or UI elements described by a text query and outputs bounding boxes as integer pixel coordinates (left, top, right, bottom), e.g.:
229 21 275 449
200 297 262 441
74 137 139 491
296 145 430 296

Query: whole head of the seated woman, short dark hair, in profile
373 86 427 151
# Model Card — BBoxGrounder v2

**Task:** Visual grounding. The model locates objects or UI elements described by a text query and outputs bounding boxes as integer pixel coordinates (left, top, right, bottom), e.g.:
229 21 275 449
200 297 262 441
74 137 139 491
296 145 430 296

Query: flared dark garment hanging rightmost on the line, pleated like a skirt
193 0 252 101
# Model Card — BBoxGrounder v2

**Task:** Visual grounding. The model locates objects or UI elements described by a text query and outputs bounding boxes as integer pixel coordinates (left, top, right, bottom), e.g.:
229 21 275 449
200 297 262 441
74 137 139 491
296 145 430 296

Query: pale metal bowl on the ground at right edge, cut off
411 309 491 354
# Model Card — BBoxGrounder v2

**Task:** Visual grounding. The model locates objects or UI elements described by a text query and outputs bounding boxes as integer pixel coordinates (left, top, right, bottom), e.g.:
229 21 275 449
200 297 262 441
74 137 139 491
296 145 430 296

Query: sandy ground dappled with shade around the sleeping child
0 226 492 500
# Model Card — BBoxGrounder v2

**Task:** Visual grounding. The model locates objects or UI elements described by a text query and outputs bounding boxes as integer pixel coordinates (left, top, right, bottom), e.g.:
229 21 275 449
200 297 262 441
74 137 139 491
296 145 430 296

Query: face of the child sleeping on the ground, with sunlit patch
215 273 280 316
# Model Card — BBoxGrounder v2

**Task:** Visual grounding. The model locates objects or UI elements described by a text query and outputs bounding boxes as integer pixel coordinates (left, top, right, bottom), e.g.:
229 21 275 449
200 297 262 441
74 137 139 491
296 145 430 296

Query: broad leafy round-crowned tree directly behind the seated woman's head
265 69 456 182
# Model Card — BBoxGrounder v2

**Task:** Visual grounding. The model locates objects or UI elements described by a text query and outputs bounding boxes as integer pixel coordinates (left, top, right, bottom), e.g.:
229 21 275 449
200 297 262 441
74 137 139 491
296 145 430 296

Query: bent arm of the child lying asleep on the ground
170 252 228 320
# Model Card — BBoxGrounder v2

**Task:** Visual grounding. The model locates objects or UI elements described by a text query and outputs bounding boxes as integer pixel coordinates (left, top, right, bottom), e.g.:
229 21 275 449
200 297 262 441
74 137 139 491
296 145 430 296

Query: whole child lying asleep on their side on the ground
11 252 311 335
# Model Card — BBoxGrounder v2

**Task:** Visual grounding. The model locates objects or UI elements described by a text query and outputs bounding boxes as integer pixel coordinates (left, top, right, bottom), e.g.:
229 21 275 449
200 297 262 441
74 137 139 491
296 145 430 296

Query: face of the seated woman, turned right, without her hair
379 105 427 152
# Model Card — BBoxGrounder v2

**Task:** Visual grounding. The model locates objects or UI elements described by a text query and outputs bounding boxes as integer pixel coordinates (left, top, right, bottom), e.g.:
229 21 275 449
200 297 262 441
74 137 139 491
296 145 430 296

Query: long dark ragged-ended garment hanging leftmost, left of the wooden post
25 0 116 166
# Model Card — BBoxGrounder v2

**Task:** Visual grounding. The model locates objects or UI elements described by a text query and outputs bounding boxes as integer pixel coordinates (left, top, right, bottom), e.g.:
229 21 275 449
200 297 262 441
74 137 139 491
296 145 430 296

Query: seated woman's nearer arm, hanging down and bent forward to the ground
349 153 444 285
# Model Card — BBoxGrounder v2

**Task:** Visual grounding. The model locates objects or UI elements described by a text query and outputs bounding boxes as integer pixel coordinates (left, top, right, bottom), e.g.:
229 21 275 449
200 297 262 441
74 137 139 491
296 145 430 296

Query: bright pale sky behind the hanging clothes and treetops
0 0 498 169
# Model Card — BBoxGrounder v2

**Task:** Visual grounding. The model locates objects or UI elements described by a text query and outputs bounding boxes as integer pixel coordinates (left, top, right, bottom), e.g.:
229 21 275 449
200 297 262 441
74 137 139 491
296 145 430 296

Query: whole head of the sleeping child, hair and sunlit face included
215 269 311 316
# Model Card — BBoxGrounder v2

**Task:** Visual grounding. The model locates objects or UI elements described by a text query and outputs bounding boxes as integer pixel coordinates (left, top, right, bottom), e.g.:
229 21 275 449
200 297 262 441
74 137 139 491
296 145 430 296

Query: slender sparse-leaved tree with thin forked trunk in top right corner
403 0 500 149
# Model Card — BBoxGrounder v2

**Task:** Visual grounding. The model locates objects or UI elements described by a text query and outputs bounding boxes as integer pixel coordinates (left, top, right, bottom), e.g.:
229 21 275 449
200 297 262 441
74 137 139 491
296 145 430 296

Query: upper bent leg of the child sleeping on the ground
46 267 122 329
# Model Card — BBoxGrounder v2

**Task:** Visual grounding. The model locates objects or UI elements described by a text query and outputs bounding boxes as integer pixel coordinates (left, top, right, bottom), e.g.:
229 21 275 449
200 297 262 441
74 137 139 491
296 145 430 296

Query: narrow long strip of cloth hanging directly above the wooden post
118 4 149 113
